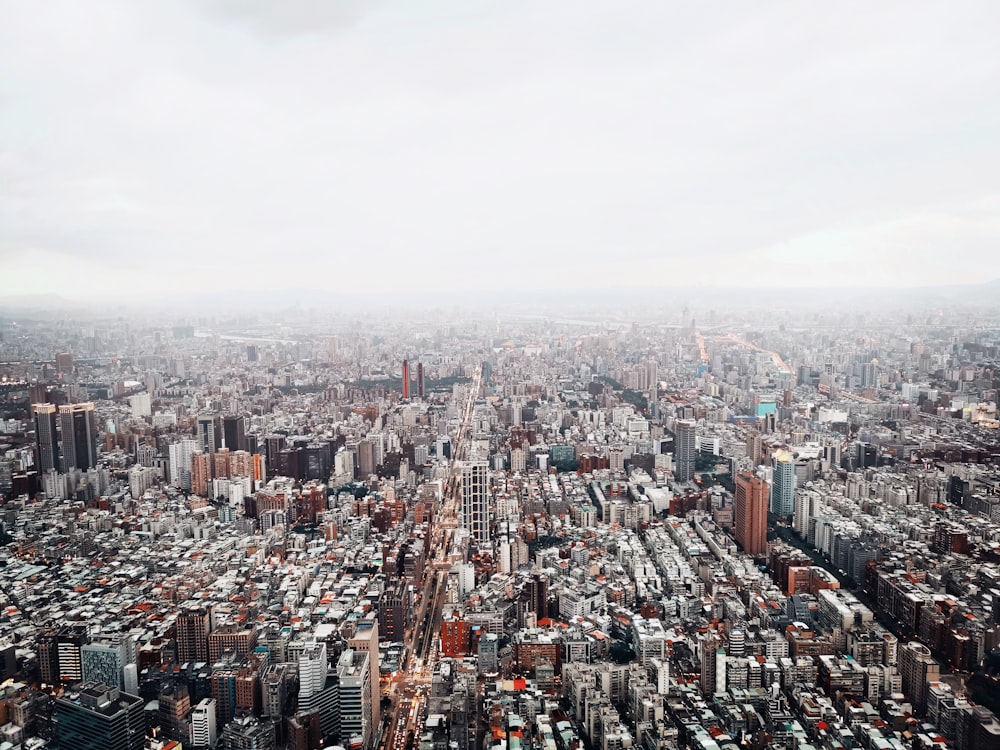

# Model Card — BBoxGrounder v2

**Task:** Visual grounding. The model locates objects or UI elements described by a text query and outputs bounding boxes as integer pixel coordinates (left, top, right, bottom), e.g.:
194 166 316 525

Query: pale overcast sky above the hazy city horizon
0 0 1000 299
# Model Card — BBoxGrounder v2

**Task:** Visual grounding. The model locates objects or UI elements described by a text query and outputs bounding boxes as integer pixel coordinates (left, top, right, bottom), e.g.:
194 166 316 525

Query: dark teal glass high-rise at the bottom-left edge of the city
54 682 146 750
